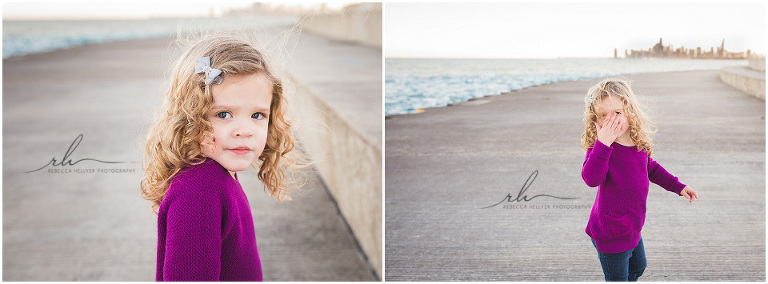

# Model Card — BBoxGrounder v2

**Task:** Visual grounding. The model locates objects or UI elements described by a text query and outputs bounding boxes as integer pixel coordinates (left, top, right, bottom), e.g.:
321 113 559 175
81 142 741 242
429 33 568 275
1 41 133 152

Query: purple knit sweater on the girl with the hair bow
155 158 262 281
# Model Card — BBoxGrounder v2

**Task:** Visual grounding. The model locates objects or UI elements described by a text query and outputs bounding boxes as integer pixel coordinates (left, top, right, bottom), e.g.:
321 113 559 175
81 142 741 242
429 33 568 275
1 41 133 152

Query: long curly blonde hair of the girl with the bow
141 35 295 214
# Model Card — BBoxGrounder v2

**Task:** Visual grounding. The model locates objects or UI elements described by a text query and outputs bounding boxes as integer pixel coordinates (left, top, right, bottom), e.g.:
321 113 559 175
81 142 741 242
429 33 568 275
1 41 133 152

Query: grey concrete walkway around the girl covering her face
385 71 765 282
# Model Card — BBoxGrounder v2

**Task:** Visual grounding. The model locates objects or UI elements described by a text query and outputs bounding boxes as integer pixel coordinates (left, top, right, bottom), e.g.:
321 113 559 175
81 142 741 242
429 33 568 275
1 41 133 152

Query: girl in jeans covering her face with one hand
581 79 698 281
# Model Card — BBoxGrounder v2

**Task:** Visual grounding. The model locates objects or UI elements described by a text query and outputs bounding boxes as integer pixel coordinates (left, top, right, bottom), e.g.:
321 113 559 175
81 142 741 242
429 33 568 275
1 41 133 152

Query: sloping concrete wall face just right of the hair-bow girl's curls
291 80 382 278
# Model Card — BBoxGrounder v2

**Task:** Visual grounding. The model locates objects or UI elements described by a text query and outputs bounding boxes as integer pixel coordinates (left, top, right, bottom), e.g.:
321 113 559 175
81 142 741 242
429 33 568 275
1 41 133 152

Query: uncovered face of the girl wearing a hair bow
200 72 272 176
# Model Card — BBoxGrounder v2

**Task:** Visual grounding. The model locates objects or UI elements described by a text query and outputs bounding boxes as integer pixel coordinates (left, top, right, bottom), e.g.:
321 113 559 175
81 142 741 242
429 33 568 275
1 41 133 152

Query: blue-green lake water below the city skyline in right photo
385 58 747 115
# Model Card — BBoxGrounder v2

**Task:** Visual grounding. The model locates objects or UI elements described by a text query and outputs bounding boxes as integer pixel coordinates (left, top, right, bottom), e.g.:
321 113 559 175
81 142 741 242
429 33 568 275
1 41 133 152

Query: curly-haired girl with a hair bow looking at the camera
141 36 294 281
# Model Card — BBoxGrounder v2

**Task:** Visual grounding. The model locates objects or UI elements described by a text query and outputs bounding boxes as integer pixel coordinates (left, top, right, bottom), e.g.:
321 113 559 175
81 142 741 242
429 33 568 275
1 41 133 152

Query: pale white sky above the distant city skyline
384 2 766 58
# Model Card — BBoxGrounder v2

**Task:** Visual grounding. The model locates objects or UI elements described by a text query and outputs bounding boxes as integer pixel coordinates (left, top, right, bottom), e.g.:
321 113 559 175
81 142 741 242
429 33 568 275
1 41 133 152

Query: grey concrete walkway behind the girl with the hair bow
3 30 373 281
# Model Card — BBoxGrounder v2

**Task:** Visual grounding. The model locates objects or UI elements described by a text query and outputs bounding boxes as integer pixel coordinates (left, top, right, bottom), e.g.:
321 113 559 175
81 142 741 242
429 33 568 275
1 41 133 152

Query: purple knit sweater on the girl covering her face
581 140 685 253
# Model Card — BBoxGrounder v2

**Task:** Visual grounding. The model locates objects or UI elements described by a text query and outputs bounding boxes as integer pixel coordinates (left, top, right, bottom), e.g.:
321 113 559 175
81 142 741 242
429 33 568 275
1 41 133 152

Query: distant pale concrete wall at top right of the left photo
301 3 382 48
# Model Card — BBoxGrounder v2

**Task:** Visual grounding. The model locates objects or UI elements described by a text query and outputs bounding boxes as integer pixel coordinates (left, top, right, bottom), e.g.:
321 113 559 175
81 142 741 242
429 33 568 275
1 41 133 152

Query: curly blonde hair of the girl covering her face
581 78 656 156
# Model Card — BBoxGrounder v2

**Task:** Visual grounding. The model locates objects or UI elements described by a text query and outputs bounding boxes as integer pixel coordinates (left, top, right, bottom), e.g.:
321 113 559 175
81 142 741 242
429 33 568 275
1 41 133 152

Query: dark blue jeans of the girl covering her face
592 238 646 281
